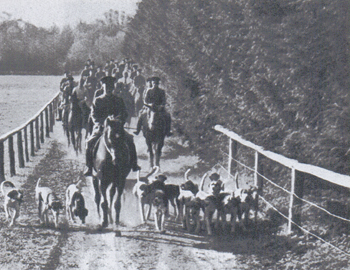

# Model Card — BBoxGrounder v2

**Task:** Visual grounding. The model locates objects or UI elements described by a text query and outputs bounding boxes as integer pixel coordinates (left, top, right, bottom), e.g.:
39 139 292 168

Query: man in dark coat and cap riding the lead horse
84 76 141 176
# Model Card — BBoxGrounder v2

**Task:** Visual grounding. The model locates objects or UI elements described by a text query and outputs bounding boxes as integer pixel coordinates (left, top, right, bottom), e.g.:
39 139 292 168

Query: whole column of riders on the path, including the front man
56 58 172 176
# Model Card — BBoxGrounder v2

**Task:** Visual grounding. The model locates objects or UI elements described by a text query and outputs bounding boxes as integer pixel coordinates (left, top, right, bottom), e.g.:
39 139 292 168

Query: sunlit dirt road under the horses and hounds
0 119 283 269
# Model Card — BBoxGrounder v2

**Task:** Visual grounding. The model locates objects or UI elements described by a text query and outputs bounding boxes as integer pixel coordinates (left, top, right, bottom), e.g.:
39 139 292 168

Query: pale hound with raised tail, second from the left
35 178 63 228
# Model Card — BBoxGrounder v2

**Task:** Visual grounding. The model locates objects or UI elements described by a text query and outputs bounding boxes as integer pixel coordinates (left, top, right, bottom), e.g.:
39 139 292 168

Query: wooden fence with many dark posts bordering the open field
0 93 59 182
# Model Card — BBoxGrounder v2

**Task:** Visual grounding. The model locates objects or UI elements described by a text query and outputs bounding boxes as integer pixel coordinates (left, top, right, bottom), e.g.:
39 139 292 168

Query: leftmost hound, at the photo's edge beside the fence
1 181 23 227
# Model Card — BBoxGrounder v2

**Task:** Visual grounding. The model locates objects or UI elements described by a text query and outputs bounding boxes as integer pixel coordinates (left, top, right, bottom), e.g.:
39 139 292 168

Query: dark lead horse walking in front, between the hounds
93 116 131 228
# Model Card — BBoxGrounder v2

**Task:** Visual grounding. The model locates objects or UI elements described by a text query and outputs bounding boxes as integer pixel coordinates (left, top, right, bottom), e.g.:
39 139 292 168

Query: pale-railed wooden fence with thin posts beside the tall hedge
214 125 350 233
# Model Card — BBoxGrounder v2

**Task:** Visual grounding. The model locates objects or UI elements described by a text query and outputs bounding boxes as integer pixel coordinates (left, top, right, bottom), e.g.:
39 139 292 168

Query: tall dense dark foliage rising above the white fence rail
123 0 350 173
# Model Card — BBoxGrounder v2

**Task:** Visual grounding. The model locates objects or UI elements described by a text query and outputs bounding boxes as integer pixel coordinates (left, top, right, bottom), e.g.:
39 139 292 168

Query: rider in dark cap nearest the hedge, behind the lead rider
134 77 173 137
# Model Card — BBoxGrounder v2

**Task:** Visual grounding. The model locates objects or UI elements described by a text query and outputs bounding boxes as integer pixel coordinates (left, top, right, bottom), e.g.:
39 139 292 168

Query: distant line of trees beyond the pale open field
0 10 129 75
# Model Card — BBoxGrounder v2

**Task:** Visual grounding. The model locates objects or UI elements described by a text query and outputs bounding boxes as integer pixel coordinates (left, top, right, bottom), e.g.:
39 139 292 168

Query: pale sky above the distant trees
0 0 141 28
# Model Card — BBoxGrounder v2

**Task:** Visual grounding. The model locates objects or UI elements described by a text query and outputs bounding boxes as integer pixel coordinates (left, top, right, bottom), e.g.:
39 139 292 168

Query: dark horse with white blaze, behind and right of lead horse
141 111 166 168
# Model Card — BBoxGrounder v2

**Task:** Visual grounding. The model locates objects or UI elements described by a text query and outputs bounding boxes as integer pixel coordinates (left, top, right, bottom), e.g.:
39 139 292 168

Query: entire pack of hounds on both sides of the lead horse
0 166 258 235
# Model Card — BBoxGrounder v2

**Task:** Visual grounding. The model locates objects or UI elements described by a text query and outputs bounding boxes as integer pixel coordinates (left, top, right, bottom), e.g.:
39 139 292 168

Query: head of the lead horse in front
103 115 125 165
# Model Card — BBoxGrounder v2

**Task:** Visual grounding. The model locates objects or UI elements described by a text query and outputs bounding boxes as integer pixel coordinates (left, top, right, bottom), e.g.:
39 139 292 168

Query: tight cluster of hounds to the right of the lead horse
133 167 258 235
